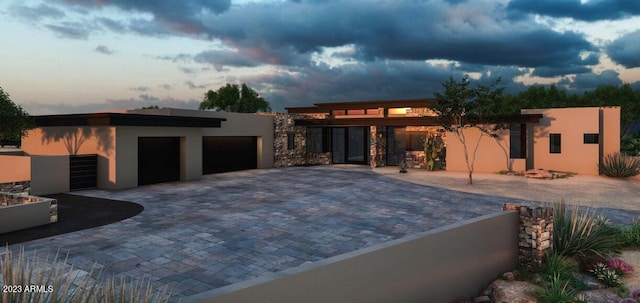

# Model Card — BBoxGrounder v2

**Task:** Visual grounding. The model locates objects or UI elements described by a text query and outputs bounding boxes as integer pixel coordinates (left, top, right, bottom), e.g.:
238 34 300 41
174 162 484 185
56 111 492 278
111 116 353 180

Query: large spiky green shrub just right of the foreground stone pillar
553 201 620 265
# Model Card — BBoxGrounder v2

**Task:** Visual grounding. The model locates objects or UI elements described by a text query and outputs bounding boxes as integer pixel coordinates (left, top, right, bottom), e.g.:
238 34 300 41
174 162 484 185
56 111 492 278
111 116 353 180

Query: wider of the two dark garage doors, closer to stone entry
202 137 258 175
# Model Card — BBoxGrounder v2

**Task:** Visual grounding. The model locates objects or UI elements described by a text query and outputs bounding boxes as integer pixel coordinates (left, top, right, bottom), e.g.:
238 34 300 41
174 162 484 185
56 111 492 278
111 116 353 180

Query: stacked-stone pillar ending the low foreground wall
502 204 553 266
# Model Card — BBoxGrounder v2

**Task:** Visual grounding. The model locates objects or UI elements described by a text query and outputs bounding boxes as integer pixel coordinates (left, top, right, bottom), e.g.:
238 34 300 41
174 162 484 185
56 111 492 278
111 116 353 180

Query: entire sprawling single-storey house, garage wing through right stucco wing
0 99 620 195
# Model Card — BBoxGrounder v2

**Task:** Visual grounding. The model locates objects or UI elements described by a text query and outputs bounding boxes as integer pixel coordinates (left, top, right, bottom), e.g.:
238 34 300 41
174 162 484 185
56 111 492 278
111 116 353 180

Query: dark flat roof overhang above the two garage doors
33 113 227 128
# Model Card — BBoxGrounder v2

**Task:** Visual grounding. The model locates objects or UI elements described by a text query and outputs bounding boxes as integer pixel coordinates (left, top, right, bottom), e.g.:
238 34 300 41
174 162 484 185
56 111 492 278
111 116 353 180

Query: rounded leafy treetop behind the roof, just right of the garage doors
200 84 271 113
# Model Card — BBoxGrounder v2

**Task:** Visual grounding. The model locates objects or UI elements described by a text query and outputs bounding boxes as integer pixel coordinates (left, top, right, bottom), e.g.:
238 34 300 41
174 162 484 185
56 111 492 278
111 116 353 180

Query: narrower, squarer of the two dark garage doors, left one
138 137 180 185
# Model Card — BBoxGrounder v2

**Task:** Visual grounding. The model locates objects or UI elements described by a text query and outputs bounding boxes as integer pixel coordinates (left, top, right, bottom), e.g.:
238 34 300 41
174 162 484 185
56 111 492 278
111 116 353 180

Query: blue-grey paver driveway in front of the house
6 166 640 299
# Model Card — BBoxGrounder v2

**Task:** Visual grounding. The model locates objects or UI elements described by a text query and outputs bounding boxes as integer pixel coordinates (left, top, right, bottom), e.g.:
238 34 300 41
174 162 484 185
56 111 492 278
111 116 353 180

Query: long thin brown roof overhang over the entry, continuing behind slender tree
294 114 542 126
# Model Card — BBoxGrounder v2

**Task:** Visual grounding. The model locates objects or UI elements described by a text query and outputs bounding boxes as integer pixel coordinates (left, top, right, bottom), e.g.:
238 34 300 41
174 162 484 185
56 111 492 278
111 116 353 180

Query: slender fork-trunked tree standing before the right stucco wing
429 76 505 185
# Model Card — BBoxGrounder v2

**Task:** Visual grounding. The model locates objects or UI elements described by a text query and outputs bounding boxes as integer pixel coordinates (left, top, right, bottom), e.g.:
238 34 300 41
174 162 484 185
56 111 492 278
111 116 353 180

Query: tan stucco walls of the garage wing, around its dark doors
22 109 273 193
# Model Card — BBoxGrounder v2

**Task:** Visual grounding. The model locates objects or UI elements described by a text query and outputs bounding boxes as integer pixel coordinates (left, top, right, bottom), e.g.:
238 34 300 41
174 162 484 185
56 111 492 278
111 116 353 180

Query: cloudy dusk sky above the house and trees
0 0 640 114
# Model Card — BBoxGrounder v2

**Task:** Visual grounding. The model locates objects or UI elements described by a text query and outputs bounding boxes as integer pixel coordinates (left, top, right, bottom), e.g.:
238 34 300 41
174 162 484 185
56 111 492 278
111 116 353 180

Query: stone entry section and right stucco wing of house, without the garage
274 99 620 175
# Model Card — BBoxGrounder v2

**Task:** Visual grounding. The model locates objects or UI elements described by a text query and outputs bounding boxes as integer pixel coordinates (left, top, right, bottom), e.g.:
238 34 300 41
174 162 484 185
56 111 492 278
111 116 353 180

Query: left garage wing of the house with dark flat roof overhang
12 109 273 194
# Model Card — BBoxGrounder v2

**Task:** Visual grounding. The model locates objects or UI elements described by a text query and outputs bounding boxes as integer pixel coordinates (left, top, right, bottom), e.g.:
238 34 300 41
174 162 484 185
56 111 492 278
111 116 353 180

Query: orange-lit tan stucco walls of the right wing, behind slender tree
446 107 620 175
